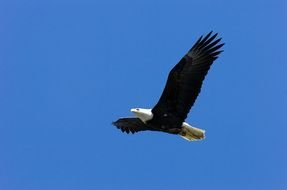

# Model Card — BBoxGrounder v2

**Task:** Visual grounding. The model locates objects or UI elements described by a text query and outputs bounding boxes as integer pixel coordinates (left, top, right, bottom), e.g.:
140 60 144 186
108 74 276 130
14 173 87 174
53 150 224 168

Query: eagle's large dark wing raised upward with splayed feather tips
152 32 224 121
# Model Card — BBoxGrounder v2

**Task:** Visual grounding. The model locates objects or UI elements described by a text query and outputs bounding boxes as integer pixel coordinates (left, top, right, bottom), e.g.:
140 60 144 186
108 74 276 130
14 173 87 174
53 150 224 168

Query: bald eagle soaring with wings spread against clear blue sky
113 32 224 141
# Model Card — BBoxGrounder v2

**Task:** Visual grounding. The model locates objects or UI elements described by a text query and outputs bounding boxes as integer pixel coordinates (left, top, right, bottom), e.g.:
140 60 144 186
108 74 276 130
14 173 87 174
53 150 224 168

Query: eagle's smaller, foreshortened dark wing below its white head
113 118 153 133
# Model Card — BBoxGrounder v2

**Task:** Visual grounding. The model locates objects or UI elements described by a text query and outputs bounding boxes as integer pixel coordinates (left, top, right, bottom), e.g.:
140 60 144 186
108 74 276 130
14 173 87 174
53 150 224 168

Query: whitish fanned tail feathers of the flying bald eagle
179 122 205 141
